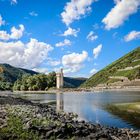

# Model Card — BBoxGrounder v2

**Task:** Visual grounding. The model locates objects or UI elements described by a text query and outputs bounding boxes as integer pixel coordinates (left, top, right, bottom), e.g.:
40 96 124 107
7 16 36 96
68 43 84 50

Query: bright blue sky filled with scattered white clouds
0 0 140 77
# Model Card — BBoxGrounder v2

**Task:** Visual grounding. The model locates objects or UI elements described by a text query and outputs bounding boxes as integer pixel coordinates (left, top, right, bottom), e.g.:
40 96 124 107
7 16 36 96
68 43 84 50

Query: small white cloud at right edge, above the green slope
124 31 140 42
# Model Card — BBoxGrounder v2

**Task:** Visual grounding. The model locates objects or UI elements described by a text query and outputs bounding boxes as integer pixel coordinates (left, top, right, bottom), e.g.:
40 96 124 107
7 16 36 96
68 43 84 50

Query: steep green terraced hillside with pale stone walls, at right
81 47 140 88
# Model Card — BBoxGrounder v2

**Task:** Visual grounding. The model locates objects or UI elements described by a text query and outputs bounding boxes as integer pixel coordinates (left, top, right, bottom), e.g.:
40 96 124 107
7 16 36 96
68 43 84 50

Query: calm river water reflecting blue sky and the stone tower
11 91 140 129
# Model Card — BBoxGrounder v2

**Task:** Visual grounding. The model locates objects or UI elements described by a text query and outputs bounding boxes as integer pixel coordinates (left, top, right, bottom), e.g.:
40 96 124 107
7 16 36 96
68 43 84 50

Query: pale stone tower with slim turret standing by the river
56 69 64 89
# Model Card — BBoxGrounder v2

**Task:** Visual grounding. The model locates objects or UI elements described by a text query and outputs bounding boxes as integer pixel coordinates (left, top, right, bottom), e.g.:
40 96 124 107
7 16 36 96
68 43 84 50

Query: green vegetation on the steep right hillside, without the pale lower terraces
80 47 140 88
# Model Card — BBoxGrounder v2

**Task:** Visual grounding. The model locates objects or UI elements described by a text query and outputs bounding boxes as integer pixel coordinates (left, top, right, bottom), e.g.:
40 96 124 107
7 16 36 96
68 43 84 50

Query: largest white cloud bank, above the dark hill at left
0 38 53 68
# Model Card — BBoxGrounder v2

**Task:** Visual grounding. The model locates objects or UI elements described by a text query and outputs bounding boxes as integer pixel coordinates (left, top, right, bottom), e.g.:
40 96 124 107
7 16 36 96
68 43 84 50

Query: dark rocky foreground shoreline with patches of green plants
0 95 140 140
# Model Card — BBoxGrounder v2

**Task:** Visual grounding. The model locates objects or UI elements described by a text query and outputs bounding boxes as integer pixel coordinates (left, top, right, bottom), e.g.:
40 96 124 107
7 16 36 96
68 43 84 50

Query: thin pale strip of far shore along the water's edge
13 87 140 94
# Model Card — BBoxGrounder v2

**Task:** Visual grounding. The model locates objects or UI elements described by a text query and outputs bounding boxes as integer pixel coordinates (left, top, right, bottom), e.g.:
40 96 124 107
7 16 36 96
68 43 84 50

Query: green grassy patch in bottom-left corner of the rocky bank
0 114 40 140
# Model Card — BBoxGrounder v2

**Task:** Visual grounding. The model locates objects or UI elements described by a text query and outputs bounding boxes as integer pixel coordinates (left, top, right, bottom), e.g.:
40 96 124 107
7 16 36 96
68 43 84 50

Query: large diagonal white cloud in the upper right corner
102 0 140 30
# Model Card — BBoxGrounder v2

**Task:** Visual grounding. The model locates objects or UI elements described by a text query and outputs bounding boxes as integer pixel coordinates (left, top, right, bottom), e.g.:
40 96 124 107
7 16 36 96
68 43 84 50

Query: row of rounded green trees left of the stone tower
13 72 56 91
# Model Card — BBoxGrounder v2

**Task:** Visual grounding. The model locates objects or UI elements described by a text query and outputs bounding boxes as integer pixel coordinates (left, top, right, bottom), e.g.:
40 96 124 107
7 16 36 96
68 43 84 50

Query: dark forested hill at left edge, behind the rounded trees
0 64 38 83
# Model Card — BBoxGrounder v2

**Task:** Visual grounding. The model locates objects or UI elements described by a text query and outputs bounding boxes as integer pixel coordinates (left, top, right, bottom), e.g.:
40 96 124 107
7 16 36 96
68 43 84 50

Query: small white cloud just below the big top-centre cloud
62 27 80 37
